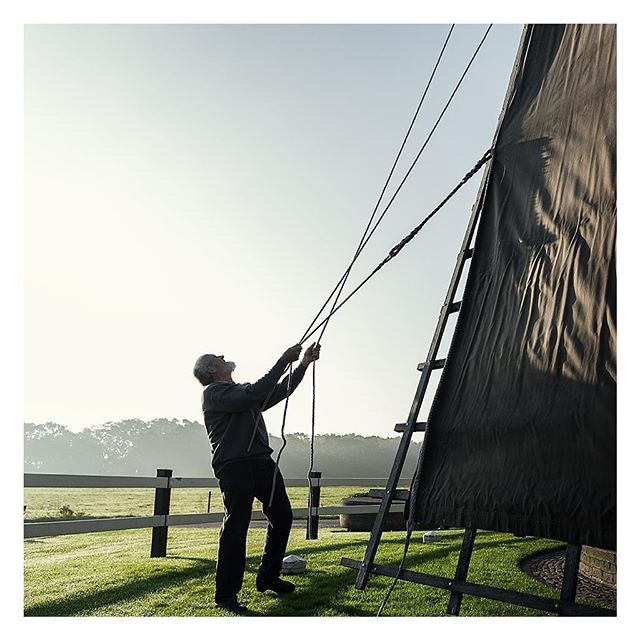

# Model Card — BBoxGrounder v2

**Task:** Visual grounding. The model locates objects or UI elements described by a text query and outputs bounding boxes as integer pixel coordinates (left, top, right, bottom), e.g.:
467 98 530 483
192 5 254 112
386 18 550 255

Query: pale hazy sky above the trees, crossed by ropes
24 25 521 436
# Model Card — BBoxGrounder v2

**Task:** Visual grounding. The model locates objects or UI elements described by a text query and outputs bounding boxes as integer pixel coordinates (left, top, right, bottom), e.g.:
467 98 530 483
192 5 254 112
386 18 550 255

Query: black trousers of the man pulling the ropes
215 459 293 602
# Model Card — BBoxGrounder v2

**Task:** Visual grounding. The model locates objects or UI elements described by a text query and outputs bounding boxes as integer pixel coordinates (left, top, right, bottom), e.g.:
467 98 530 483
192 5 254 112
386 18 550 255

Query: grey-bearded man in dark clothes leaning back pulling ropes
193 343 320 613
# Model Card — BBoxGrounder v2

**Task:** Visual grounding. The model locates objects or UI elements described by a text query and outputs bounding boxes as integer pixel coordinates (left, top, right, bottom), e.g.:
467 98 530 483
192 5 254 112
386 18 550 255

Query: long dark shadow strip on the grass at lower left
24 558 215 616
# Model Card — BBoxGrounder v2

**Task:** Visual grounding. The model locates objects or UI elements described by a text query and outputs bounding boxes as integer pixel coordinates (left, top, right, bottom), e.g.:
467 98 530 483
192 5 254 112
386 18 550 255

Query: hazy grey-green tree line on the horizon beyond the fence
24 418 419 478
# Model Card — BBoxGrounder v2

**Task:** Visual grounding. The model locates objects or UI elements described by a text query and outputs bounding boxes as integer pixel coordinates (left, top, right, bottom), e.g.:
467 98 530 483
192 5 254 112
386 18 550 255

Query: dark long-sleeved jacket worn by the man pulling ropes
202 360 306 477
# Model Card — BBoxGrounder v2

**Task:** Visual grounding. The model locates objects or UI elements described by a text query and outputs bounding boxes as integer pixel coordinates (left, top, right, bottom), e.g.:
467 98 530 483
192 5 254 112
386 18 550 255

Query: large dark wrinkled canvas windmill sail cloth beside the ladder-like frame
414 25 616 549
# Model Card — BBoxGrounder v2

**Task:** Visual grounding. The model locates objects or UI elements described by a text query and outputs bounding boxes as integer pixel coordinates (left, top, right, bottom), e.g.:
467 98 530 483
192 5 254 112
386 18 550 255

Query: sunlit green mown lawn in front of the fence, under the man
24 524 594 616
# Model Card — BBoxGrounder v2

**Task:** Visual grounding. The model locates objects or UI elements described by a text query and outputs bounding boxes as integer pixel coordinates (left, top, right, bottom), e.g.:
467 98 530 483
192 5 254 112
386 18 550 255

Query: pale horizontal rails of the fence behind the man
24 473 410 555
